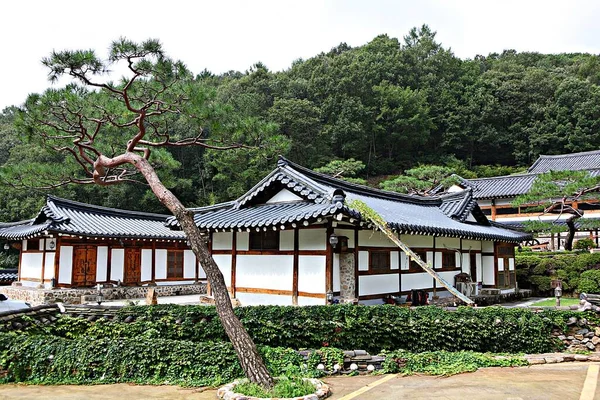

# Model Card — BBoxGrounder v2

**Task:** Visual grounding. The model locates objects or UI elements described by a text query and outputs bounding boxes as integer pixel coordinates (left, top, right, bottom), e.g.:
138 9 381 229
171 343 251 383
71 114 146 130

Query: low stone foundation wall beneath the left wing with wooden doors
0 282 206 306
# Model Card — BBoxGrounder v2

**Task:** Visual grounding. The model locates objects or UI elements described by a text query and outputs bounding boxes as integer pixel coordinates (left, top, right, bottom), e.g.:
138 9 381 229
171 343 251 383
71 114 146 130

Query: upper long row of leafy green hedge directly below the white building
18 305 597 353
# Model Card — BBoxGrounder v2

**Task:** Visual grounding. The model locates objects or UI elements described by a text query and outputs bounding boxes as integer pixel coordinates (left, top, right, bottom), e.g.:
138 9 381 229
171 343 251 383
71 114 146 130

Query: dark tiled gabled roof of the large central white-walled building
176 158 530 242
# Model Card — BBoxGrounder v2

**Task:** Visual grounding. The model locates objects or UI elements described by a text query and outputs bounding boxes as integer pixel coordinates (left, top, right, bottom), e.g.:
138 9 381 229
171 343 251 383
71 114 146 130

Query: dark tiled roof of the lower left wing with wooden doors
0 196 185 240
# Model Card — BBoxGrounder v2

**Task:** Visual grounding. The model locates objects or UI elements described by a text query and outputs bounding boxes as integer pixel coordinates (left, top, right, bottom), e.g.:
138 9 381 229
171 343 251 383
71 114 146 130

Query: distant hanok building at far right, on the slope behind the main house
449 150 600 249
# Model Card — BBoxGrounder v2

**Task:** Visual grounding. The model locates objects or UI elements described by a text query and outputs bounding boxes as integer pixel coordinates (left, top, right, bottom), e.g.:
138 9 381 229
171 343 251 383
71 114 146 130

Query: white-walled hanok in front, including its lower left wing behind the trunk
0 158 530 305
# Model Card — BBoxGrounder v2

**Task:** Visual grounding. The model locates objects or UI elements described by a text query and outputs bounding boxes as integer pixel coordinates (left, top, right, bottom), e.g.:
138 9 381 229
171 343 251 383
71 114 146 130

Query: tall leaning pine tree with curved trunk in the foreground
21 38 273 387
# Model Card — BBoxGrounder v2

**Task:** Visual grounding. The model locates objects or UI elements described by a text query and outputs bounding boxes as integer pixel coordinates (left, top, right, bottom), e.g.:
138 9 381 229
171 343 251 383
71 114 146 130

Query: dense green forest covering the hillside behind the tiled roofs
0 26 600 221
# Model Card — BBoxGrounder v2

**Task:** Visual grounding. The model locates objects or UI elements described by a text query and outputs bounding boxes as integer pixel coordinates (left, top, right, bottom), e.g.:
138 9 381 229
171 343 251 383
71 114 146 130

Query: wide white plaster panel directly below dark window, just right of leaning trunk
236 255 292 290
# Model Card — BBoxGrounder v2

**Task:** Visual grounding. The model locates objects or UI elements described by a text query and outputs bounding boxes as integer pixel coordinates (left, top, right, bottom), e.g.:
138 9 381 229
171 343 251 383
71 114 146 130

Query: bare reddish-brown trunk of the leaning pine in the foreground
116 153 273 388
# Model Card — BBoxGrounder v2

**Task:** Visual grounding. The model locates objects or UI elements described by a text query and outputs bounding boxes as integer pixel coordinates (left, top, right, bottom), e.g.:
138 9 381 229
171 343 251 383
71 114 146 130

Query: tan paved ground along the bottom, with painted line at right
0 363 600 400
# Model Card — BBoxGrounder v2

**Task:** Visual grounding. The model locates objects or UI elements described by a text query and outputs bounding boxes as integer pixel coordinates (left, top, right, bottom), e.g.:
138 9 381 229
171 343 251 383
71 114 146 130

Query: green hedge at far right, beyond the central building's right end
515 253 600 295
